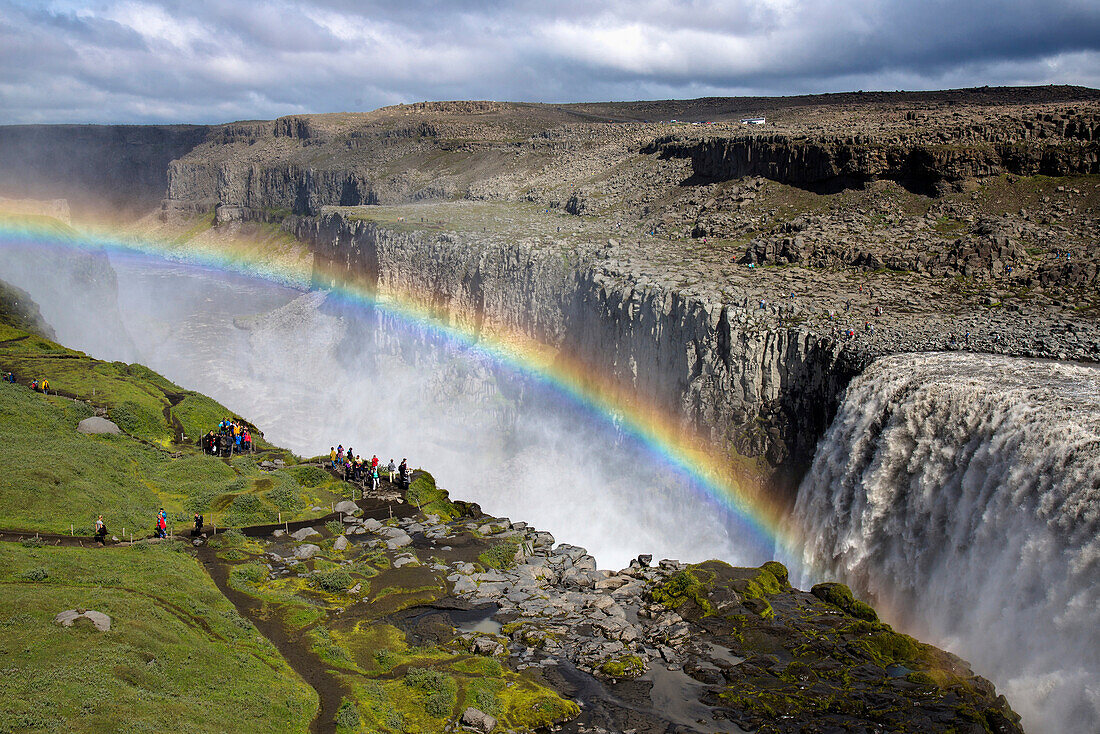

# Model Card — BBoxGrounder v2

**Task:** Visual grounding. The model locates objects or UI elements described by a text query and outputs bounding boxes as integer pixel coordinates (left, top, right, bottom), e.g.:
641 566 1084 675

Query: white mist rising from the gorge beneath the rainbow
51 253 773 569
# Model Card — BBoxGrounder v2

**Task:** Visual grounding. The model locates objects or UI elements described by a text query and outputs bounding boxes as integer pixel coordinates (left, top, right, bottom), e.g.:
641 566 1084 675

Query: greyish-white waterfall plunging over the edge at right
795 353 1100 734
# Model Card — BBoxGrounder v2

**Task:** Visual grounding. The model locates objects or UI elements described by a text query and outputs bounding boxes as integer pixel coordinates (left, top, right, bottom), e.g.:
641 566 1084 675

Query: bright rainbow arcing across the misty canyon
0 216 802 560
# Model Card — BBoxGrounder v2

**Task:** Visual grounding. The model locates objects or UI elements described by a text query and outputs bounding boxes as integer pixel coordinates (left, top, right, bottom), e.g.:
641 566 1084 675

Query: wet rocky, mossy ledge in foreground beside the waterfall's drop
227 473 1022 734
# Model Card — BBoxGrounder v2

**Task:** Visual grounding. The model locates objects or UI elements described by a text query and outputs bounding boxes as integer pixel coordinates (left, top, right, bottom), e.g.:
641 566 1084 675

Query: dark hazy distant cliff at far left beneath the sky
0 124 209 216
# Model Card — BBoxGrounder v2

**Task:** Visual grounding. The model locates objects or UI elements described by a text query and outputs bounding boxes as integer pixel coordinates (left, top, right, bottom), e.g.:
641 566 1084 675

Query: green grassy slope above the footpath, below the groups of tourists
0 290 347 537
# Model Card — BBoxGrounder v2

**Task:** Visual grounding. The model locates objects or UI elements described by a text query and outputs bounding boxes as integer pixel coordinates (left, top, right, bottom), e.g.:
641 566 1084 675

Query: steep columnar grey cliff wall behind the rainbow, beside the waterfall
296 212 864 499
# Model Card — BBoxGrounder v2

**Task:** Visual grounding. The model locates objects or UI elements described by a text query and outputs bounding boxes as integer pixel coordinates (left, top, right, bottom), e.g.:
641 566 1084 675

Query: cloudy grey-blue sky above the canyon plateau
0 0 1100 123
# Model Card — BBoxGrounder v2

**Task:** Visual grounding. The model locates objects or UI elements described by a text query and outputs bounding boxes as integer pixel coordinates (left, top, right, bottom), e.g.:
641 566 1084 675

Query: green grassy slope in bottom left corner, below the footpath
0 544 317 733
